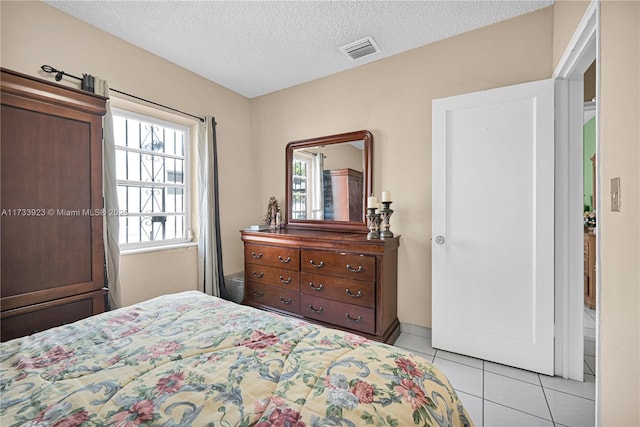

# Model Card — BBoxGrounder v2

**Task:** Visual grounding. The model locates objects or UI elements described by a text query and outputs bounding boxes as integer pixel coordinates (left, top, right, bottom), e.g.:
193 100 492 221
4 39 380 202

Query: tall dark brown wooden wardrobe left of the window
0 69 106 341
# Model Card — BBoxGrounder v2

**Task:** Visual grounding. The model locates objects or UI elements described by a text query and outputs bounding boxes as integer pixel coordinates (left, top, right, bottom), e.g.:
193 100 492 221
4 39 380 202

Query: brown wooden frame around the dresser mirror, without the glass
285 130 373 232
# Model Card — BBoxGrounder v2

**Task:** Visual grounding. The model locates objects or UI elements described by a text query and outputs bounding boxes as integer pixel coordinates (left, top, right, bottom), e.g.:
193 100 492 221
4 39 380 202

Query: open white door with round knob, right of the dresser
432 80 554 375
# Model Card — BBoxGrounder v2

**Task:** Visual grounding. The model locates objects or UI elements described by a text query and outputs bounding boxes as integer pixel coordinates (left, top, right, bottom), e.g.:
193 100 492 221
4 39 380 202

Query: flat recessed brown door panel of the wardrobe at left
2 106 92 297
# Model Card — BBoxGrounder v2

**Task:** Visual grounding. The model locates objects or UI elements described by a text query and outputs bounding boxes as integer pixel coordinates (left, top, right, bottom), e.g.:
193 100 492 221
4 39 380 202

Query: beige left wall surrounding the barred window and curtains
0 1 262 302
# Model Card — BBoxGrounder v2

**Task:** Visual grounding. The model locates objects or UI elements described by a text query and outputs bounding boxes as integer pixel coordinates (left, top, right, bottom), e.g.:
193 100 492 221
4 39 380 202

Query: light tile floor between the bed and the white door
395 307 595 427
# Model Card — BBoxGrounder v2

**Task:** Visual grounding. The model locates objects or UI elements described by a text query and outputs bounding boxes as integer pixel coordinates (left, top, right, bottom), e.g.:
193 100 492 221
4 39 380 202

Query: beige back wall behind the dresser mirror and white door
251 8 553 326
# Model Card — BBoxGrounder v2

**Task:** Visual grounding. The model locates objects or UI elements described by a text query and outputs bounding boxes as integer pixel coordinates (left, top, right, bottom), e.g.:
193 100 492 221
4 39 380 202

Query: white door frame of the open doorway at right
553 0 602 392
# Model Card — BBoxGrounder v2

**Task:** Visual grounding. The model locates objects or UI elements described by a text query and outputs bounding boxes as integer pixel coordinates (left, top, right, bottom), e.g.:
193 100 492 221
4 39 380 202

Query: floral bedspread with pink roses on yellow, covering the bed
0 291 472 427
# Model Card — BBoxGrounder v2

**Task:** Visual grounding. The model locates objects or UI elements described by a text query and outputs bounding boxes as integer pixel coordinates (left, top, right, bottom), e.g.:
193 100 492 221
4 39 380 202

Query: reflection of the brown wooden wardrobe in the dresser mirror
323 168 364 221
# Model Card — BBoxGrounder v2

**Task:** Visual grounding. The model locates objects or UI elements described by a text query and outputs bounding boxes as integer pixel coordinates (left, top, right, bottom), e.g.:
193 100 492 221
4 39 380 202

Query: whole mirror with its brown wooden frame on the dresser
286 130 373 231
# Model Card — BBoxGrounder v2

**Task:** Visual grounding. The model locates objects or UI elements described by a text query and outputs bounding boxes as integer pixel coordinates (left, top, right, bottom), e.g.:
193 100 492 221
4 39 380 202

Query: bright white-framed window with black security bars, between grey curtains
113 109 190 249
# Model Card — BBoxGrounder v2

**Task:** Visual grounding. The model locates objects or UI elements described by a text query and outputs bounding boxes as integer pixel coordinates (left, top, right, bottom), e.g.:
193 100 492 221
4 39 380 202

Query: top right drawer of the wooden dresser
300 250 376 282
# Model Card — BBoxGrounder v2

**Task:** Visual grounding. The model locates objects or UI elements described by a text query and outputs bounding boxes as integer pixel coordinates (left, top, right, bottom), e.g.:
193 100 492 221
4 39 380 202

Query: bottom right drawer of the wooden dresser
300 295 376 334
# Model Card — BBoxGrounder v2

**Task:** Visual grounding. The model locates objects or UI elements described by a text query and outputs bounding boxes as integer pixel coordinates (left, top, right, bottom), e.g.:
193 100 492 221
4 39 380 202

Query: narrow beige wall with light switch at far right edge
599 1 640 426
